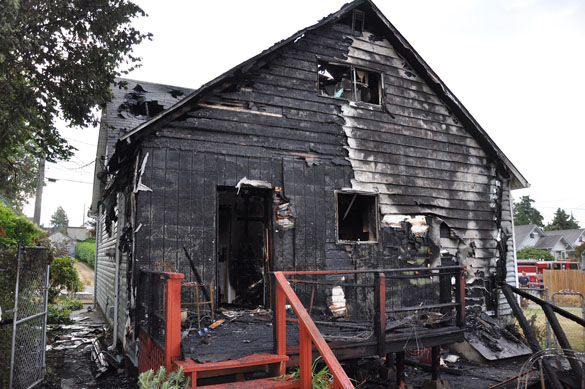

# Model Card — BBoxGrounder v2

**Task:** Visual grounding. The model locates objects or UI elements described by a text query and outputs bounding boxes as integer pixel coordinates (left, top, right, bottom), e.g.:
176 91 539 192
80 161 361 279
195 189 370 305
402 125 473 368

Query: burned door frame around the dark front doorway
215 185 274 307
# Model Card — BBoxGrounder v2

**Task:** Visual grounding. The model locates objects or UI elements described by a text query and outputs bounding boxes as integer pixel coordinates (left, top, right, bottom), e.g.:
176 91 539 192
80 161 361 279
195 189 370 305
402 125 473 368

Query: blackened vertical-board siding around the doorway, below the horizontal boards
136 146 352 281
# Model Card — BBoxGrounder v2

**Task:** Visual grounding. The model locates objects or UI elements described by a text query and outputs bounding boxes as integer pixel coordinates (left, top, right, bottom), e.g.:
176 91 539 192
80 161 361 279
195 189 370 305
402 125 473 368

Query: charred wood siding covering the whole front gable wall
130 20 509 312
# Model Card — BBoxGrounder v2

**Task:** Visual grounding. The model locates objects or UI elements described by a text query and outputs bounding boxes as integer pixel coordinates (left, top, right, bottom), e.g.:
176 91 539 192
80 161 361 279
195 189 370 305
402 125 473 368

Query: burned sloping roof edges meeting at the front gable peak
112 0 530 189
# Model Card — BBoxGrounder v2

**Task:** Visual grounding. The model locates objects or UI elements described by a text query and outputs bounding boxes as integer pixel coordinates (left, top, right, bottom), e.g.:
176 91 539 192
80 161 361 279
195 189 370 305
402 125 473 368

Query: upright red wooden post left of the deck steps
165 273 185 371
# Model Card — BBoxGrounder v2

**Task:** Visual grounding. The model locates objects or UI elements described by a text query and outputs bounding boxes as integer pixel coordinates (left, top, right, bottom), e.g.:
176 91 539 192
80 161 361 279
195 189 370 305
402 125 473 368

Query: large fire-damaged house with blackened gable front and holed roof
92 0 528 358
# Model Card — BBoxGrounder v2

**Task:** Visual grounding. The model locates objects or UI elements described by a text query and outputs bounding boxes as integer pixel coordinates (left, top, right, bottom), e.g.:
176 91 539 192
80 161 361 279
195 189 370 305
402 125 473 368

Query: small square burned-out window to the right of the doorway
336 192 378 242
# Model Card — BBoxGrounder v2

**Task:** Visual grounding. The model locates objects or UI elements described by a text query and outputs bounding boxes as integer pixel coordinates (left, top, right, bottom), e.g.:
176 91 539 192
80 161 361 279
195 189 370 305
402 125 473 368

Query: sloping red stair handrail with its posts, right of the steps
273 272 354 389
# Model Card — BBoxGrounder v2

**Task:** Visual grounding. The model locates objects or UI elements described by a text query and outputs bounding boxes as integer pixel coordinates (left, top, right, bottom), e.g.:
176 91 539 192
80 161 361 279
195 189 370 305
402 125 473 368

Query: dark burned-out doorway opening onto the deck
217 187 272 307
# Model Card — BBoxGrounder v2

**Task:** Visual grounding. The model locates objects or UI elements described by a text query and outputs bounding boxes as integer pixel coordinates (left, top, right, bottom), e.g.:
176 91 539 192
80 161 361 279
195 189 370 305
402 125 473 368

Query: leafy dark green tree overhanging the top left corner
0 0 150 206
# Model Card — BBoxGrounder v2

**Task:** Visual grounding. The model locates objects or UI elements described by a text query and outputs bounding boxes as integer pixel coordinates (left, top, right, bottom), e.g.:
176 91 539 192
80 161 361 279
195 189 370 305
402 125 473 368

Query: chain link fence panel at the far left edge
0 247 50 389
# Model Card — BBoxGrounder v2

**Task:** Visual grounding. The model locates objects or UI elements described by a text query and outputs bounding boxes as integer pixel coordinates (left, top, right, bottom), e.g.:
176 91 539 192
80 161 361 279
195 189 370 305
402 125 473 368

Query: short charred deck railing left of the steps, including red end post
136 270 184 373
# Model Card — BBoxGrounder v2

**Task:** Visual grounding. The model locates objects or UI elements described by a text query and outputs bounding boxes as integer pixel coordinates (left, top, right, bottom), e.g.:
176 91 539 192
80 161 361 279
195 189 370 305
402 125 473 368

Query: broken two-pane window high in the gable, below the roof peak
318 61 382 104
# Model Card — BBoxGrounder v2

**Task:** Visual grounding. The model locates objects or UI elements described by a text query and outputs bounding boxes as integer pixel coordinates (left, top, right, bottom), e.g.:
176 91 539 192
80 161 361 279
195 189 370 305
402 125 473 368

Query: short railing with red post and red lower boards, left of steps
138 271 184 373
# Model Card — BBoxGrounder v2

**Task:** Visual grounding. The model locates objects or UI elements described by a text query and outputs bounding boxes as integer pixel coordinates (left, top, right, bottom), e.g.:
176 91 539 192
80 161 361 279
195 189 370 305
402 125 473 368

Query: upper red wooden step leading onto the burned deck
174 353 288 387
